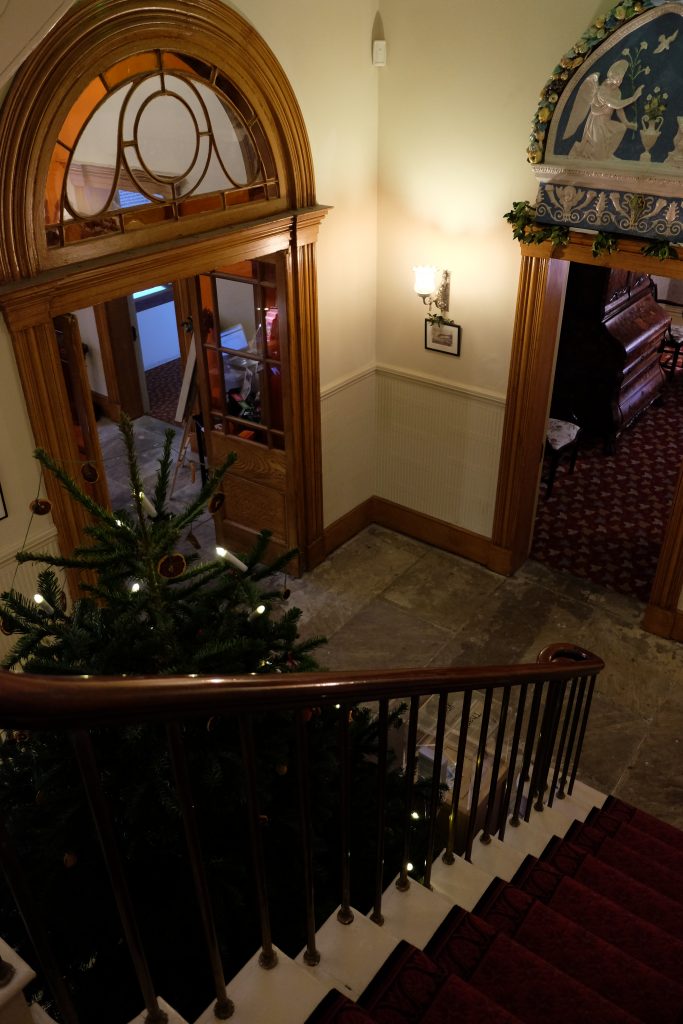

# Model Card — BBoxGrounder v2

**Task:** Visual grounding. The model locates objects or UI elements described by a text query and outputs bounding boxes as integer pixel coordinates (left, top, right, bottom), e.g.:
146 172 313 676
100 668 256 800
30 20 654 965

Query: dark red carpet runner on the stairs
306 798 683 1024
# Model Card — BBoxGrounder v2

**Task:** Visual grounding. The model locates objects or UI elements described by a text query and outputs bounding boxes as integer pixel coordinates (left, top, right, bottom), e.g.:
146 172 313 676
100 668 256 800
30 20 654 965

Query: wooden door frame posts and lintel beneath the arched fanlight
0 207 327 568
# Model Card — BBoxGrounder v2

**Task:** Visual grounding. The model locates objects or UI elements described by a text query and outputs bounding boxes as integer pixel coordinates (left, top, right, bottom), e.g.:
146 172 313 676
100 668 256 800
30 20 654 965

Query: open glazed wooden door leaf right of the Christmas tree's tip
196 257 298 572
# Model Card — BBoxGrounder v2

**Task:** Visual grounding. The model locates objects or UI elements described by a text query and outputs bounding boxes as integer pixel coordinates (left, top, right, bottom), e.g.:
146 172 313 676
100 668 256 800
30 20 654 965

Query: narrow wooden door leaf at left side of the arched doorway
53 313 110 506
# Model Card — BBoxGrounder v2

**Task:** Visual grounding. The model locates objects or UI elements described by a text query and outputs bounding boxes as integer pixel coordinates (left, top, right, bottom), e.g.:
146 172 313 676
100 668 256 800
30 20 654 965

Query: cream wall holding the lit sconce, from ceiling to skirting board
370 0 610 537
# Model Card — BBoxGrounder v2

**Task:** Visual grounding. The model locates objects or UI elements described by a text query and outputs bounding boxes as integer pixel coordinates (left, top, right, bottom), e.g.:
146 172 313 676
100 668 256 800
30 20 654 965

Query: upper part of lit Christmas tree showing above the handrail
0 417 322 675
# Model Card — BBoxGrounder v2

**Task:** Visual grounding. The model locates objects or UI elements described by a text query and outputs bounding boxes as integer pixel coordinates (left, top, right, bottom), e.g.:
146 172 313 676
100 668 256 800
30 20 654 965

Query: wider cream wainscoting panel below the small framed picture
376 367 505 537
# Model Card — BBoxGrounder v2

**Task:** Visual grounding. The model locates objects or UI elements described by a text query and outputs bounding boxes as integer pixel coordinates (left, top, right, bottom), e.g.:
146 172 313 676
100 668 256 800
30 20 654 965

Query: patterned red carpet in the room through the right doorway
531 371 683 601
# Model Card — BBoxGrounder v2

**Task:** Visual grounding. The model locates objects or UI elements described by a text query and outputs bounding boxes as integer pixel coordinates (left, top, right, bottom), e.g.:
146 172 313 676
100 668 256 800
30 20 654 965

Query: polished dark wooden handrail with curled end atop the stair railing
0 644 604 729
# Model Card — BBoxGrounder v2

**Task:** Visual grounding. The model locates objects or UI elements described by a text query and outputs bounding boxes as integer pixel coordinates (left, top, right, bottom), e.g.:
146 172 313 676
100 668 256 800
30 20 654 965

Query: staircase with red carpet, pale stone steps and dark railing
0 645 683 1024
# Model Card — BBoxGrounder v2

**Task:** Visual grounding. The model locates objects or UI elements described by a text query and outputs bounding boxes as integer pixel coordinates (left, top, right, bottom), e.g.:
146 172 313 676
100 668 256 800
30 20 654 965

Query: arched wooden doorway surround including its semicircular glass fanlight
0 0 327 581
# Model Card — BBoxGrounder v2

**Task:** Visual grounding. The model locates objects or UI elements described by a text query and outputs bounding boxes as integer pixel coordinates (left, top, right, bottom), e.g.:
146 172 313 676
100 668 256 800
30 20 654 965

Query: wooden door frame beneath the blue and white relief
488 232 683 640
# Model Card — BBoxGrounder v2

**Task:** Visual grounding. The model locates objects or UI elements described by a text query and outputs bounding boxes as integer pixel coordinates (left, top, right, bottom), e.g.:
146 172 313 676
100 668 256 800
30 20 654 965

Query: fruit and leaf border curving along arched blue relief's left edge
526 0 654 163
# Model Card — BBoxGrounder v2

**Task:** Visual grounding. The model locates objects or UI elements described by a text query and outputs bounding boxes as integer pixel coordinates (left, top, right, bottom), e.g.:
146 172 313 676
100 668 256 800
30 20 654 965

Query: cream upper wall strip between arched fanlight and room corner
232 0 379 391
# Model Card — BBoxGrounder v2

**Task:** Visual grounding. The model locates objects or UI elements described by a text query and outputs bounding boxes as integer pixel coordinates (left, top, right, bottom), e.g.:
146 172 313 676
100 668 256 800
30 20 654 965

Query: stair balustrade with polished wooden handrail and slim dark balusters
0 644 603 1024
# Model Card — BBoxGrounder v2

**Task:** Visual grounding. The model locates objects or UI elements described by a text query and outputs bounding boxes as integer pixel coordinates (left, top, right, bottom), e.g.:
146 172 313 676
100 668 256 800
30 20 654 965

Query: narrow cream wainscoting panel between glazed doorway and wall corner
321 368 377 526
